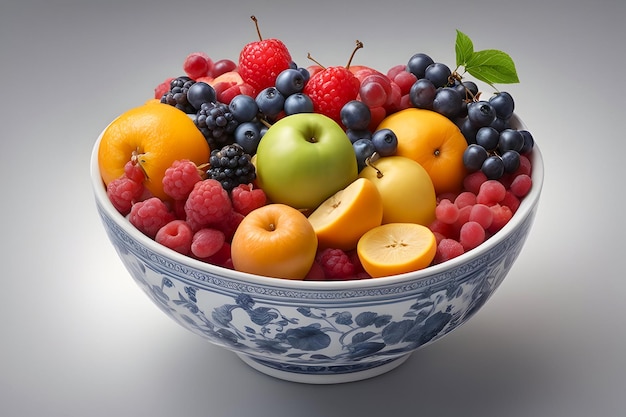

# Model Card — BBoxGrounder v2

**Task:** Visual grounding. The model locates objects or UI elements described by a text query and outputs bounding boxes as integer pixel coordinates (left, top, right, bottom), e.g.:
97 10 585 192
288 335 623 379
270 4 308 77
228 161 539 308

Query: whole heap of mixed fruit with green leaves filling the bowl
98 17 534 280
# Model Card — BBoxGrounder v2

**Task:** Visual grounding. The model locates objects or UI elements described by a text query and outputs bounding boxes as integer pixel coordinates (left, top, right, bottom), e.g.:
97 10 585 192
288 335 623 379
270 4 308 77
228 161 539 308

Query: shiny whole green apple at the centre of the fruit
255 113 358 210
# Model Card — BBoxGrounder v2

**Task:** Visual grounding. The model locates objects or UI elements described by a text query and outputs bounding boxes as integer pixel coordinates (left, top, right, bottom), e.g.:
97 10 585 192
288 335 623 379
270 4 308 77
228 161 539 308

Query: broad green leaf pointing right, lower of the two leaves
464 49 519 85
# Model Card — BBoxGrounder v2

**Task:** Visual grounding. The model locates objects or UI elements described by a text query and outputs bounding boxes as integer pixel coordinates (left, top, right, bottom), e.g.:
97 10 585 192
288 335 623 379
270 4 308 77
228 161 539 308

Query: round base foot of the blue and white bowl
237 353 411 384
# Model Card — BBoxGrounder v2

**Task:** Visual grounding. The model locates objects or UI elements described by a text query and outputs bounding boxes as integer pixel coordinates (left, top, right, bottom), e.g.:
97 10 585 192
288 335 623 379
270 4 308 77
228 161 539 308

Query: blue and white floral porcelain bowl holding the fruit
91 114 543 384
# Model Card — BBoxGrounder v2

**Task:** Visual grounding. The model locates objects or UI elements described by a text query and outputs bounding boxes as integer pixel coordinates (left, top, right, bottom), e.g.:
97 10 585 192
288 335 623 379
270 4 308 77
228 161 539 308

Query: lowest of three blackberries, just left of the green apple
207 143 256 193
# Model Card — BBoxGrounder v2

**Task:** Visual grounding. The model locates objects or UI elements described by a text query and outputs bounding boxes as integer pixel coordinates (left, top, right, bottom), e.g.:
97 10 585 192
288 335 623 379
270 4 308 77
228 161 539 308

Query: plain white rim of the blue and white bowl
90 113 544 291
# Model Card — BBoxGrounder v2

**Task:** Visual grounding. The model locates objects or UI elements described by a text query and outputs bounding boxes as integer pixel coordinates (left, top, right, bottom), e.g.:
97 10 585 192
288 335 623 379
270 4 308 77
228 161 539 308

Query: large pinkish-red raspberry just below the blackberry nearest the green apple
185 179 232 230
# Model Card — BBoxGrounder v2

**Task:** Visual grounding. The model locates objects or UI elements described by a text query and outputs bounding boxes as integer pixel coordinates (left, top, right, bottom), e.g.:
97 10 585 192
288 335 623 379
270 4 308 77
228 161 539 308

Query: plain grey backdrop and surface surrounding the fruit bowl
0 0 626 417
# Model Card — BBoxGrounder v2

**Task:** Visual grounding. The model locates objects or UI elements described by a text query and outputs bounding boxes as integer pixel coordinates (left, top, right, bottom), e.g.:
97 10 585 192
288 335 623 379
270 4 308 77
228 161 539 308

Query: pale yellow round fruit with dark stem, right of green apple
359 155 437 226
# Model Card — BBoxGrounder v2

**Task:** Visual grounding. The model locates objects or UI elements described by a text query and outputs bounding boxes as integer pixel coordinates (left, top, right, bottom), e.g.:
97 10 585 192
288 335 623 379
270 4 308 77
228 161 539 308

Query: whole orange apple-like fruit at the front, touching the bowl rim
231 203 317 279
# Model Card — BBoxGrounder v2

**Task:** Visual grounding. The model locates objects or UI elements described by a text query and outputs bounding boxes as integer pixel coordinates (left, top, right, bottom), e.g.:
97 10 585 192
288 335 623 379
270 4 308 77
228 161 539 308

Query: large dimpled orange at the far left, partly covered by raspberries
98 101 210 200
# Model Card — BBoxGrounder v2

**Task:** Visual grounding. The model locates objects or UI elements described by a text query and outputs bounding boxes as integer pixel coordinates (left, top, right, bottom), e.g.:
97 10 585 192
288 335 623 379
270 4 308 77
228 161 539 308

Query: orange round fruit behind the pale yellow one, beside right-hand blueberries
378 108 467 194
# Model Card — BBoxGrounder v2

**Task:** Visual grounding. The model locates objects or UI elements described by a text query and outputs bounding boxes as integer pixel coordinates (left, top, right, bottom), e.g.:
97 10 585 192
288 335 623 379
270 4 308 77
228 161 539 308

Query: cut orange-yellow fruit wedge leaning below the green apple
308 178 383 251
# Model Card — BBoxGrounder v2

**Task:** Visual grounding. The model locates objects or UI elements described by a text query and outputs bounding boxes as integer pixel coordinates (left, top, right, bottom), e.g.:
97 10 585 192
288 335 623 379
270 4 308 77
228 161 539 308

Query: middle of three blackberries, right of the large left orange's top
194 102 239 149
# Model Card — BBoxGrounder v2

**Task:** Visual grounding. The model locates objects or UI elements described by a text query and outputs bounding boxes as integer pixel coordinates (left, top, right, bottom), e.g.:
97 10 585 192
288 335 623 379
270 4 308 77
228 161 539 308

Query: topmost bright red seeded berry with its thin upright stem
238 16 292 95
